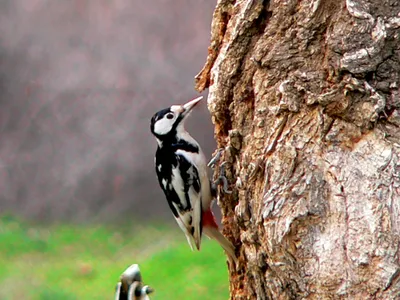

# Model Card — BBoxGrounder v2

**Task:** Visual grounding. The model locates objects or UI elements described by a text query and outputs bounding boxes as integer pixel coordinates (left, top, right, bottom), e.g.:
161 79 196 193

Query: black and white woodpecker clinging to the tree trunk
150 97 237 262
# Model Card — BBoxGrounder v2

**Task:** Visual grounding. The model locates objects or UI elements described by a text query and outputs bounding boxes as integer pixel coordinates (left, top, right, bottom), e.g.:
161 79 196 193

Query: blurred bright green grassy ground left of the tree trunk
0 217 229 300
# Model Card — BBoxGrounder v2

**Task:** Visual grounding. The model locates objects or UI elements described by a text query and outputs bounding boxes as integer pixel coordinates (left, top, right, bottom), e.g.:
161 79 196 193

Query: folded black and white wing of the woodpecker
171 153 202 250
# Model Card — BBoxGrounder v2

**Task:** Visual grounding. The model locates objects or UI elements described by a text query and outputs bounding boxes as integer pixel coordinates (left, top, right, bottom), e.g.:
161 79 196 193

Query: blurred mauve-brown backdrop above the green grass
0 0 216 222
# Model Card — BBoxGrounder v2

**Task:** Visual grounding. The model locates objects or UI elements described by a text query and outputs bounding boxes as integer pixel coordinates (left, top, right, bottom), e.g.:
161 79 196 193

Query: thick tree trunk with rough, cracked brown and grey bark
196 0 400 299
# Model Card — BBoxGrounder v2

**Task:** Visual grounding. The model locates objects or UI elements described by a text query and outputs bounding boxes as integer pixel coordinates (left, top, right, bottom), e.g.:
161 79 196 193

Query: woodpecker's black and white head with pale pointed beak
150 97 203 140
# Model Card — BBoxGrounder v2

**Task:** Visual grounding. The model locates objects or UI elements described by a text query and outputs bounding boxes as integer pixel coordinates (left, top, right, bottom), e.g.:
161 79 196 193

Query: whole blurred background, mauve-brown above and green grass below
0 0 228 299
